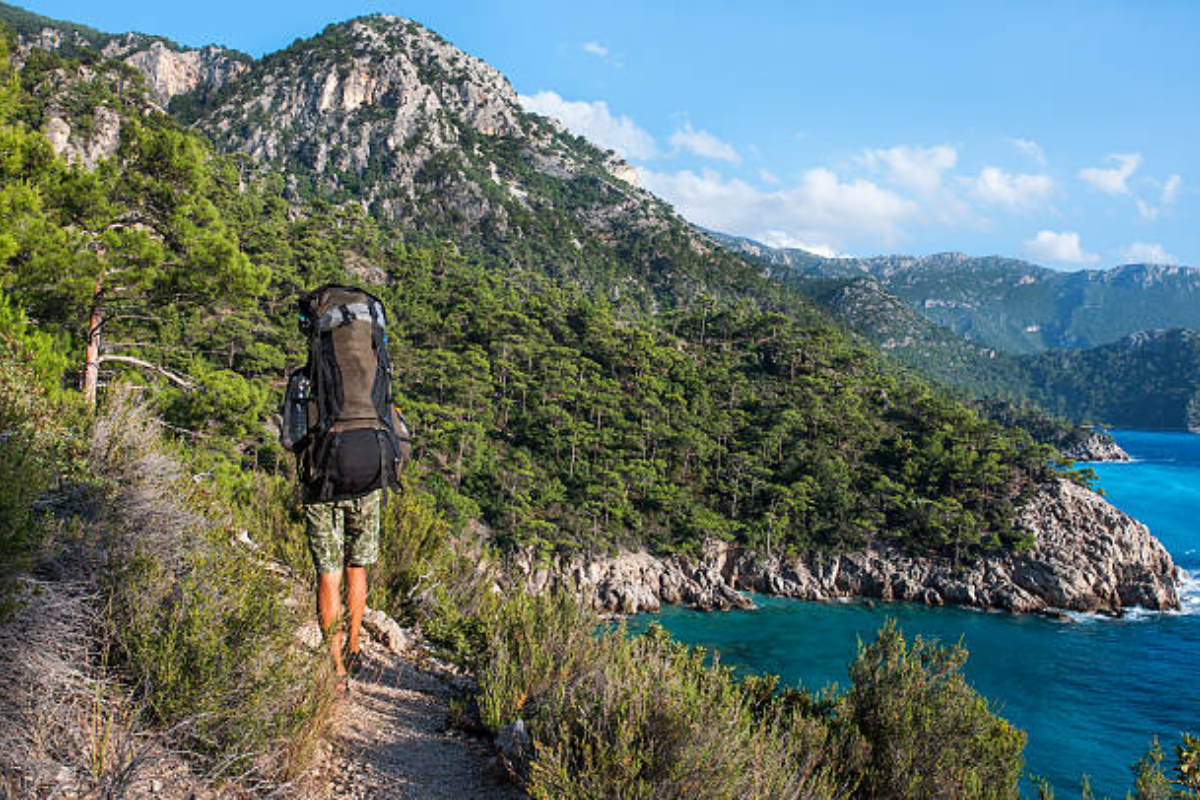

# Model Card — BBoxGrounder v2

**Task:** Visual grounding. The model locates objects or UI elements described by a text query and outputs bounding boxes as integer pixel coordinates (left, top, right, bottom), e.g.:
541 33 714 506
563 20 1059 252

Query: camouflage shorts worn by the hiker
304 489 383 575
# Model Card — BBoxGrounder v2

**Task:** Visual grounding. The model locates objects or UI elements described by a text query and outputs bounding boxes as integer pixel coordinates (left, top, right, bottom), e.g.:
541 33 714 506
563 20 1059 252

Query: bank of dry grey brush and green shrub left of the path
0 391 330 798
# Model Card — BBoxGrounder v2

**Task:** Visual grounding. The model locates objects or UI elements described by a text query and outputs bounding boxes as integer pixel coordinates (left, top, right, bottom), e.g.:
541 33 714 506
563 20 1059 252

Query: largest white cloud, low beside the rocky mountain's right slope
638 169 920 252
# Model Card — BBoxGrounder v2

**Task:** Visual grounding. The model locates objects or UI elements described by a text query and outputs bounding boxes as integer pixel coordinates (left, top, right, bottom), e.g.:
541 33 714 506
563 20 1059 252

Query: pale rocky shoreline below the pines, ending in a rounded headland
514 480 1180 615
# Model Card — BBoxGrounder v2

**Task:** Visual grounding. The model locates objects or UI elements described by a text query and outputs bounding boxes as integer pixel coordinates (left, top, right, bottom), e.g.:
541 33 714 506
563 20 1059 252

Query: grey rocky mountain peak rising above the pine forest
164 16 808 313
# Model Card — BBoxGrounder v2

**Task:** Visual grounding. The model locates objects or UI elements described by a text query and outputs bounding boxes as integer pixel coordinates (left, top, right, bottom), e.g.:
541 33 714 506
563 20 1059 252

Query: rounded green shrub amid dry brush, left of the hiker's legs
109 546 326 772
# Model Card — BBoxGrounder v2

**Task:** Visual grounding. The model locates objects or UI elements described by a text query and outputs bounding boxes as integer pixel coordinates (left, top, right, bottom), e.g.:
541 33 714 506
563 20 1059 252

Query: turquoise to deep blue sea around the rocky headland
634 431 1200 798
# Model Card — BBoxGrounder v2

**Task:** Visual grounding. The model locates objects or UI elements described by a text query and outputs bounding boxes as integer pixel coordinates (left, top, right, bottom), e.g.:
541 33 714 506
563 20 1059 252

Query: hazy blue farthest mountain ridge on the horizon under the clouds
719 236 1200 354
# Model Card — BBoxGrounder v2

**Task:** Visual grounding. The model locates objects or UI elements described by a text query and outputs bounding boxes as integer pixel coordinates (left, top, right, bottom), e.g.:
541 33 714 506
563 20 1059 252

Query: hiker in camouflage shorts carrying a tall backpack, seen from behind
281 284 410 691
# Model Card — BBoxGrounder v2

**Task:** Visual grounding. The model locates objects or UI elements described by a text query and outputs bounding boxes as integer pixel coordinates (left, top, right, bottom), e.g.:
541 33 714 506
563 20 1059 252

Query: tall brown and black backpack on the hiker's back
282 284 412 501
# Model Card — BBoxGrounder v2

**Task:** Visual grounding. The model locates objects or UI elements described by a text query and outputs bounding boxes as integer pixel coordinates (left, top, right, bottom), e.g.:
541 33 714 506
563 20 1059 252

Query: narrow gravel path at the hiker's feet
323 644 524 800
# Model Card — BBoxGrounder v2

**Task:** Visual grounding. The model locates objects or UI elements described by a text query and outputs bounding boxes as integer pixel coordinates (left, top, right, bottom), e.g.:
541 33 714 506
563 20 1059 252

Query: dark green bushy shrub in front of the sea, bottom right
838 621 1025 800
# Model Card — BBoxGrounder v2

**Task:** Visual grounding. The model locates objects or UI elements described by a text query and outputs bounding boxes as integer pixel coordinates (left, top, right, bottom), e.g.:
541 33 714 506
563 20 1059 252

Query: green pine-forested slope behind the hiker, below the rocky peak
4 15 1080 563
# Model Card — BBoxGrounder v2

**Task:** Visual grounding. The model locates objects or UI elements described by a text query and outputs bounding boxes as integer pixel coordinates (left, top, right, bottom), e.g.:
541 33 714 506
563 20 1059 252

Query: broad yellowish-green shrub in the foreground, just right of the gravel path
465 591 848 798
